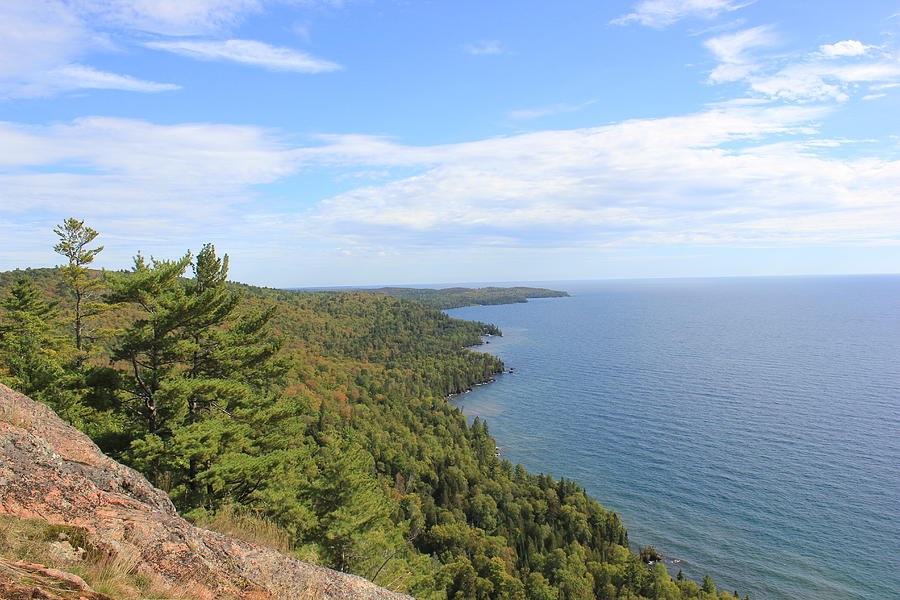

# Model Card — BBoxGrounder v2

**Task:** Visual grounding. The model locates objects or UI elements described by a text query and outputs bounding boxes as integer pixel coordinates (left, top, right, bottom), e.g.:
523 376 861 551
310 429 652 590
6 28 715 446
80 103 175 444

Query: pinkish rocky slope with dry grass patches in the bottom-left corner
0 385 409 600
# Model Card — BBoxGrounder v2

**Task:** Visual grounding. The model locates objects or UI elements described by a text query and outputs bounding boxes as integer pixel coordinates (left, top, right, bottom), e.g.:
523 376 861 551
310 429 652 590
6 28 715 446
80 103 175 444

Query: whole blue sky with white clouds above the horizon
0 0 900 287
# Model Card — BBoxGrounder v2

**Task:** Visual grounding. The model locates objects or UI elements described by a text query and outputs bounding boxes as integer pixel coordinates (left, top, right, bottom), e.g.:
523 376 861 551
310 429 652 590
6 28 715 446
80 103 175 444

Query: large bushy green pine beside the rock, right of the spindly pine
109 244 283 510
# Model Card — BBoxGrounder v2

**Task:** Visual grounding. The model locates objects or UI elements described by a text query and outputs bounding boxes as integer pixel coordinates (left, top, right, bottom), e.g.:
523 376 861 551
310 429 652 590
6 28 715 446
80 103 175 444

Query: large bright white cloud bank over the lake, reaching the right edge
270 104 900 248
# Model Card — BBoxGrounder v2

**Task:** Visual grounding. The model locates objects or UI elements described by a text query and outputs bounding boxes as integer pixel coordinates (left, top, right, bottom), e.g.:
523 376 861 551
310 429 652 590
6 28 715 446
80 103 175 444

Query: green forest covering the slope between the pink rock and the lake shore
0 219 744 600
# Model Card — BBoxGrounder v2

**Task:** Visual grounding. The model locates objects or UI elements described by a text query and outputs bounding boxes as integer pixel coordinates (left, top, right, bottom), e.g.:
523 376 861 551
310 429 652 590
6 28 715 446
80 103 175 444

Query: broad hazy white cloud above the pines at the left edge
0 117 294 222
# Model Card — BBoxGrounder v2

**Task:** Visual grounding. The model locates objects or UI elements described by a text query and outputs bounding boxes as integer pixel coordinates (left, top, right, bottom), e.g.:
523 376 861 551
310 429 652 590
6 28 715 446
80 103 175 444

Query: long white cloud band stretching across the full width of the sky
7 101 900 272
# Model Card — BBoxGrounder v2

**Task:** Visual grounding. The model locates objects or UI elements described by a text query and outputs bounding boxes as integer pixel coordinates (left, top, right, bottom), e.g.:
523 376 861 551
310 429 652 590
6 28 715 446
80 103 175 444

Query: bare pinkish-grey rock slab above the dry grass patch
0 385 410 600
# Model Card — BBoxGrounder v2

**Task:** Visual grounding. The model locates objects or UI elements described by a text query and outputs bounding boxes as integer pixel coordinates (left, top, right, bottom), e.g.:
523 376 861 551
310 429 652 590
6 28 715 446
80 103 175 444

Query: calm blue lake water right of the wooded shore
447 276 900 600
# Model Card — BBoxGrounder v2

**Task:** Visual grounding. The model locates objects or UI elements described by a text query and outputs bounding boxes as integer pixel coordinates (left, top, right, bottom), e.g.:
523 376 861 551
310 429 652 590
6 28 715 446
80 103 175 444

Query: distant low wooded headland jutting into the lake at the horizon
334 287 569 309
